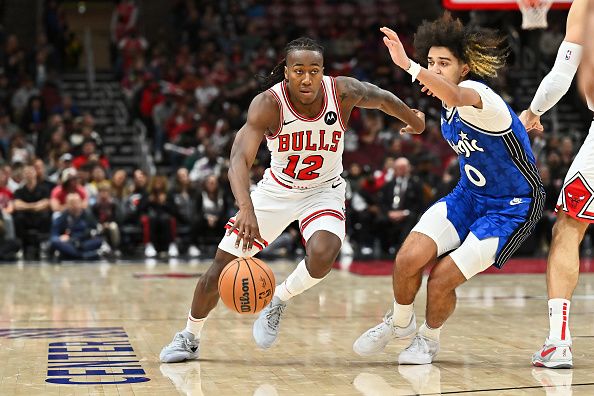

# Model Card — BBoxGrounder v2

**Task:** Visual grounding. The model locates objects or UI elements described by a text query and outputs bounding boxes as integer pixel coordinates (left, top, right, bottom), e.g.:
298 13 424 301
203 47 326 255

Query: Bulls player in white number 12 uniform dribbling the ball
160 38 425 362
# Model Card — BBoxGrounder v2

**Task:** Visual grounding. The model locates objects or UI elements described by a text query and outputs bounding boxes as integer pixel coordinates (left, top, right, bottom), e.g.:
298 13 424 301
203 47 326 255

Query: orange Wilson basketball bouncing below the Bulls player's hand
219 257 275 314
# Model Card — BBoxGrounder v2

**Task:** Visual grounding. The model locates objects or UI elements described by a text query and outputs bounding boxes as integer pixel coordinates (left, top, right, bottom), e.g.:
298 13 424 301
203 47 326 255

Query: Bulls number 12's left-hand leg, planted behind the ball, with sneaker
159 248 237 363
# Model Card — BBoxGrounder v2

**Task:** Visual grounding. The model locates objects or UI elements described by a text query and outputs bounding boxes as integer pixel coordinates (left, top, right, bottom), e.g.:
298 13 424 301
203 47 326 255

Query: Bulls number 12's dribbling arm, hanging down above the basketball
227 92 280 251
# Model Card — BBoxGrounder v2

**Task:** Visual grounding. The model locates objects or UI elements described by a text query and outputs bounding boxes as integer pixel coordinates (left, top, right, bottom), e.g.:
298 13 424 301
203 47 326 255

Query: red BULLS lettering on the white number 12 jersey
278 129 342 152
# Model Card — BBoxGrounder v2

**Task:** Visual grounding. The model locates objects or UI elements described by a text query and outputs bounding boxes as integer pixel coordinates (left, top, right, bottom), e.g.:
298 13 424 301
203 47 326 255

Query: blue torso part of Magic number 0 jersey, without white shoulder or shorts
441 82 543 198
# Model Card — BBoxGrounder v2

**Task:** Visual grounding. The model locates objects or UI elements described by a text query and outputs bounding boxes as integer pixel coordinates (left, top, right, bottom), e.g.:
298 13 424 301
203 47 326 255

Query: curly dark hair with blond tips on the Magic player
414 12 509 79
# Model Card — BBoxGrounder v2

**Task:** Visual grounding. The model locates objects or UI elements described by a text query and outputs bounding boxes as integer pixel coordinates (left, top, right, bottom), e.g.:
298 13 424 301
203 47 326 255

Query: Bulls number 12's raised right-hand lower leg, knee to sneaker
253 230 342 349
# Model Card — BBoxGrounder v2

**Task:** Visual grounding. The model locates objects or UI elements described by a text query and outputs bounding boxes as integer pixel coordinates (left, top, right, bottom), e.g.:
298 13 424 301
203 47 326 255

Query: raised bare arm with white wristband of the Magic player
380 27 483 109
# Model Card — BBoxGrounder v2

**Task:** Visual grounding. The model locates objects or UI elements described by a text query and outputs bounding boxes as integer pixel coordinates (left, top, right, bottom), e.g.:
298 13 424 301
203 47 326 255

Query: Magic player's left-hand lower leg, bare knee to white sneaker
353 231 437 356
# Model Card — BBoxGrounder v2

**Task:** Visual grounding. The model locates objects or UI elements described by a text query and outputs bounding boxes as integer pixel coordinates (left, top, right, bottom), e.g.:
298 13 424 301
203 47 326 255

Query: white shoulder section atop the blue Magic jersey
458 80 512 132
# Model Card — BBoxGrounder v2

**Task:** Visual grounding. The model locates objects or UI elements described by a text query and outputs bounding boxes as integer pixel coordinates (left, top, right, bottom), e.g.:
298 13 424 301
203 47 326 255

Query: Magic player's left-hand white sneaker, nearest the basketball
353 311 417 356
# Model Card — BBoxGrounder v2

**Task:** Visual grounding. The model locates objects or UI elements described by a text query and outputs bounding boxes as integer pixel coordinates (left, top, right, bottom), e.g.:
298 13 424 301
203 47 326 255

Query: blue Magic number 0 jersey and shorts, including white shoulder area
432 81 545 267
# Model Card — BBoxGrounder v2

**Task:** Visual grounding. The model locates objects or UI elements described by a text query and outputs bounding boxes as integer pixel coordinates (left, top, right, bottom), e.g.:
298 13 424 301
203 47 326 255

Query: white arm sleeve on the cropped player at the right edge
530 41 582 116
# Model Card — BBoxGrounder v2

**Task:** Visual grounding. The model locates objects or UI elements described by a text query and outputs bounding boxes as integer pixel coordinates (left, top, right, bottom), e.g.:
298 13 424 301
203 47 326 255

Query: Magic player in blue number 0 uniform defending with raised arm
353 13 545 364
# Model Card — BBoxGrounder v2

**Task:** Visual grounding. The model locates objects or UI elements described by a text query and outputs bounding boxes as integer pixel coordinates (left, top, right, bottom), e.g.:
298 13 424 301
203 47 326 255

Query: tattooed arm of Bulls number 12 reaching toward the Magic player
336 77 425 134
